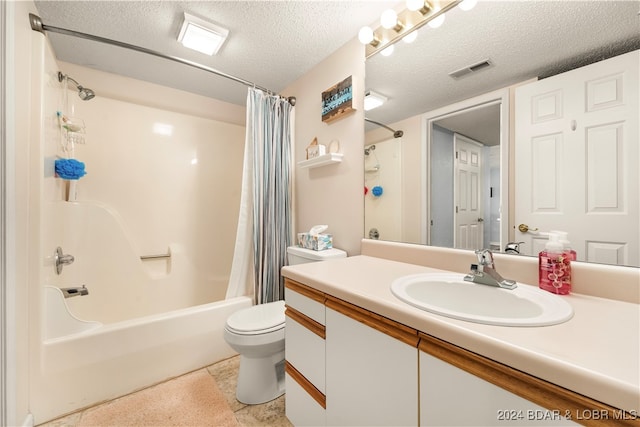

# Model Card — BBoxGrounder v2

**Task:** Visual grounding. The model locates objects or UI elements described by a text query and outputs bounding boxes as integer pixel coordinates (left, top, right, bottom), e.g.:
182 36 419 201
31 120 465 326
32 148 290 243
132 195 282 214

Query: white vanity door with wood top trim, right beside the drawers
326 296 418 426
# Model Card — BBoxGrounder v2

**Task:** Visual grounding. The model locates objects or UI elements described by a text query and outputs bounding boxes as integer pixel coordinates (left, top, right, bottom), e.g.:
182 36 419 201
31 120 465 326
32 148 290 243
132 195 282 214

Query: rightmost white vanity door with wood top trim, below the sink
419 333 592 426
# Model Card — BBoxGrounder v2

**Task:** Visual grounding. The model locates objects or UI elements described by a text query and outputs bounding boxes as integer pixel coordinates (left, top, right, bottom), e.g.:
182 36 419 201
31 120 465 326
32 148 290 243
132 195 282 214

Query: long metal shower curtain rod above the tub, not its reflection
29 13 295 105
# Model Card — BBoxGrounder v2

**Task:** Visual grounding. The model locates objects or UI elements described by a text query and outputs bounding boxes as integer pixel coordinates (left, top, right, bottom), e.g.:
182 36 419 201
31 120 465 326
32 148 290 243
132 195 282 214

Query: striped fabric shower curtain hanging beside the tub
226 88 294 304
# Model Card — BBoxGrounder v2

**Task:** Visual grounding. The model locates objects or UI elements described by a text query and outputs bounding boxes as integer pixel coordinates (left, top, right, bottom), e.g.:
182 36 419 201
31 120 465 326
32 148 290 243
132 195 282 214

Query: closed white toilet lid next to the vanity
227 301 284 334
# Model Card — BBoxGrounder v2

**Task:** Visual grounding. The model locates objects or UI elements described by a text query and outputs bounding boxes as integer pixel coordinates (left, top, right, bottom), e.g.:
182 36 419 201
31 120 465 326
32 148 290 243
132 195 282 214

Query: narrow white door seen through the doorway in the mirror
453 134 484 249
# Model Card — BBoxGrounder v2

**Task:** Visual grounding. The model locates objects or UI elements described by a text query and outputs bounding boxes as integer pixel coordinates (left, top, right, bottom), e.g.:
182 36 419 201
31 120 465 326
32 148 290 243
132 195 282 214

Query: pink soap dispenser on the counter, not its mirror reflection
538 231 571 295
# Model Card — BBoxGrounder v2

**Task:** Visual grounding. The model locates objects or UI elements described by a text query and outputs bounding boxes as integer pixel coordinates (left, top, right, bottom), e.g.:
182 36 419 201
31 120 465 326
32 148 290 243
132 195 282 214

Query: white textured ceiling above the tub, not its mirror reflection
36 1 396 105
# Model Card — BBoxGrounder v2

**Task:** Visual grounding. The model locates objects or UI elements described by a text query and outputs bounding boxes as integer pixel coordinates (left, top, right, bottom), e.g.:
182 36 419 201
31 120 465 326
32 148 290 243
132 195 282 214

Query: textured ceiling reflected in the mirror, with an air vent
367 0 640 134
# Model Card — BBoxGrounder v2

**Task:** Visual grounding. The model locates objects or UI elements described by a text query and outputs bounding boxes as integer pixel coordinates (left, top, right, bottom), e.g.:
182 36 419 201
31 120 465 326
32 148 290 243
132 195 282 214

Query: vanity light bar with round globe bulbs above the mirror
358 0 462 58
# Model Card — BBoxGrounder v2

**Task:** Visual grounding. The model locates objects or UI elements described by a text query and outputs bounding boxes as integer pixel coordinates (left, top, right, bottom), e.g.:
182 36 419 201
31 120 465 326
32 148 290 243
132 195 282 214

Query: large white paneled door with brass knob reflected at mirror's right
515 51 640 266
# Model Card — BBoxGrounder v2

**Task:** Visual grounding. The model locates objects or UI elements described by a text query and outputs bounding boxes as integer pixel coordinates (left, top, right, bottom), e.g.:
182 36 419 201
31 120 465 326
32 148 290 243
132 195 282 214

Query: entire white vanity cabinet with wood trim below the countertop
285 279 640 427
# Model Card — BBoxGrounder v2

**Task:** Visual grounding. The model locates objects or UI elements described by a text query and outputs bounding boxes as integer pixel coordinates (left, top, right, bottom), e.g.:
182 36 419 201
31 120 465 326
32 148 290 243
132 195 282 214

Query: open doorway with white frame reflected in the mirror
422 91 509 251
